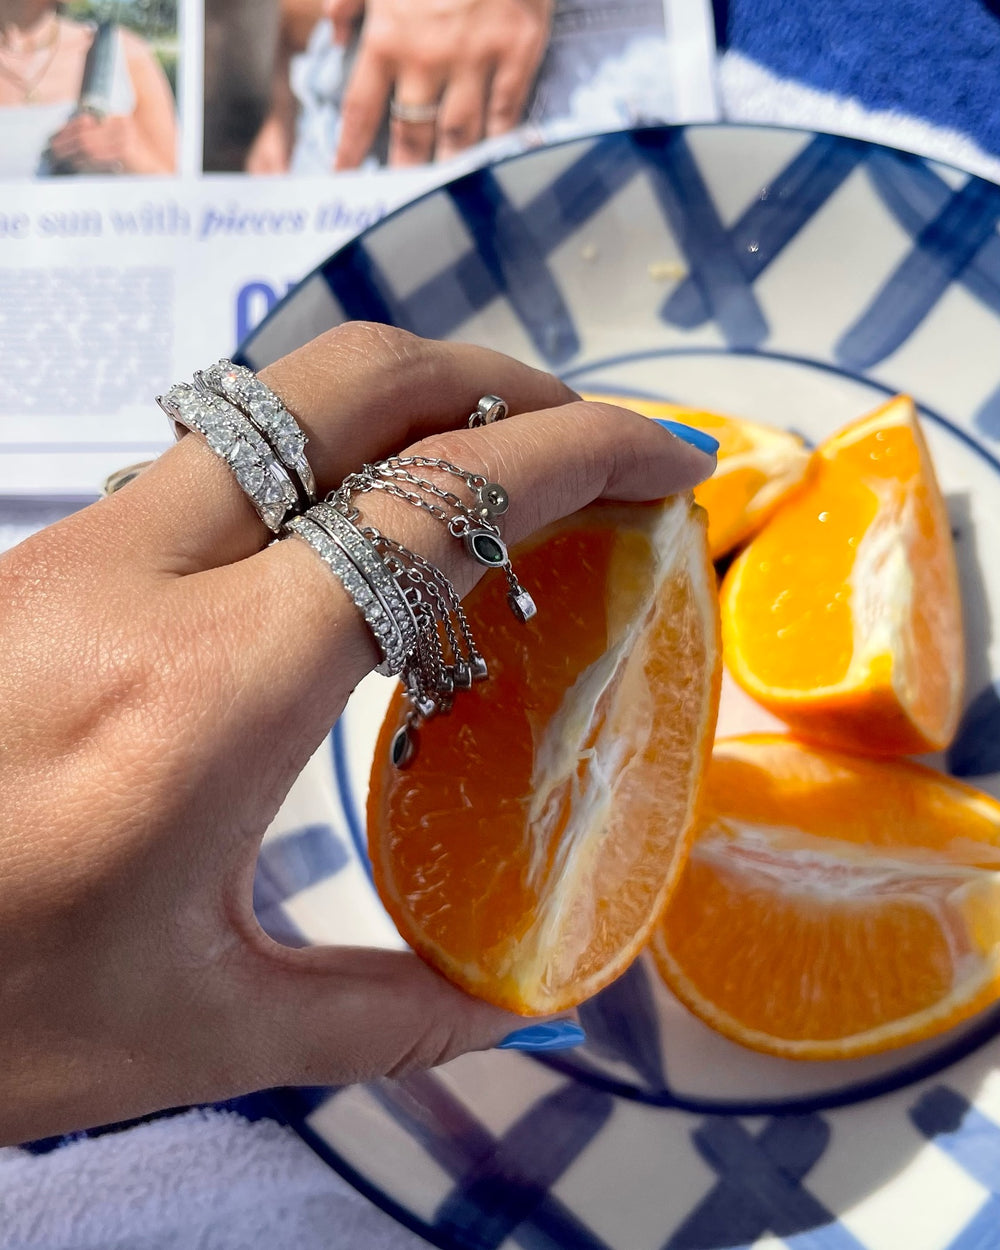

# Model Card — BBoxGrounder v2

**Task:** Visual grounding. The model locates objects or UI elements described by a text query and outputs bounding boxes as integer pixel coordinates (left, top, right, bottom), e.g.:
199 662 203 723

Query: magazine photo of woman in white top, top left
0 0 178 178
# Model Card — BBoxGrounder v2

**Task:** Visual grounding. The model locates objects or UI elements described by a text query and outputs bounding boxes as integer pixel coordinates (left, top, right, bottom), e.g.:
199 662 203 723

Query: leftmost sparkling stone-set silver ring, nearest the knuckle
156 383 299 534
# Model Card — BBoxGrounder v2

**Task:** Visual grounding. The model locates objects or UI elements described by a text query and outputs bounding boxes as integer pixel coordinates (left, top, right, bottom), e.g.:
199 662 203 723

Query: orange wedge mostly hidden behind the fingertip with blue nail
585 395 809 560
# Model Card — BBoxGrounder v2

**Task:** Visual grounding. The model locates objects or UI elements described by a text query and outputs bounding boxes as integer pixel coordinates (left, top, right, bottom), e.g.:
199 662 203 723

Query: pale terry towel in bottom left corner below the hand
0 1110 426 1250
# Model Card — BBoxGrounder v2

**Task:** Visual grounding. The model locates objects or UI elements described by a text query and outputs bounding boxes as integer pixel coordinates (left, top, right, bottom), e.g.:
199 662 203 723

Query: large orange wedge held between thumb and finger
368 496 720 1015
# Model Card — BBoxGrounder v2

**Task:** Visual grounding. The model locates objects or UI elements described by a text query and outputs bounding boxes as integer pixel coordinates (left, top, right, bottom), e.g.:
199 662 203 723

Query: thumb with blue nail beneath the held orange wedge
234 946 584 1089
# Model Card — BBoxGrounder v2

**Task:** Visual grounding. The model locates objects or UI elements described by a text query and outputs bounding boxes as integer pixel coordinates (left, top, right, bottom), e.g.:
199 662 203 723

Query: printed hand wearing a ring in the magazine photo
336 0 553 169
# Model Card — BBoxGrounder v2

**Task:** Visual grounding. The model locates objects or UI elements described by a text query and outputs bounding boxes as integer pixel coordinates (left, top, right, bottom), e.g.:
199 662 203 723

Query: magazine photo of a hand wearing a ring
205 0 671 174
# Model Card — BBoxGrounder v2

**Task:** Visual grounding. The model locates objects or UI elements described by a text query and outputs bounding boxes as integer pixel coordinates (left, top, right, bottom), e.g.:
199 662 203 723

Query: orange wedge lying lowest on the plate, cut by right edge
653 735 1000 1059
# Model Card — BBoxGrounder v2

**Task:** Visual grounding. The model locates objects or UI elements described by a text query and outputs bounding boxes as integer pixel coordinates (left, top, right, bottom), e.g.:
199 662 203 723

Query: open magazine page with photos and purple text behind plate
0 0 718 507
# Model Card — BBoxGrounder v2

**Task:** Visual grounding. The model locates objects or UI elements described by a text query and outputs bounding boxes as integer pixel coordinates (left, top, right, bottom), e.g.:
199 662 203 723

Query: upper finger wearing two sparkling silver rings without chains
95 323 576 574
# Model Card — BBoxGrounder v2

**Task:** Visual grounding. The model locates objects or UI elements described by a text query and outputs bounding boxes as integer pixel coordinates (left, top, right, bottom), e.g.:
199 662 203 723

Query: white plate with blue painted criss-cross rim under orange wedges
243 126 1000 1250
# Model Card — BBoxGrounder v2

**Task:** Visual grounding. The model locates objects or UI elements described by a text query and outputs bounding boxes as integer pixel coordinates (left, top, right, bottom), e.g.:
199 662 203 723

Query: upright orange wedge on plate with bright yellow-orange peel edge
723 396 964 754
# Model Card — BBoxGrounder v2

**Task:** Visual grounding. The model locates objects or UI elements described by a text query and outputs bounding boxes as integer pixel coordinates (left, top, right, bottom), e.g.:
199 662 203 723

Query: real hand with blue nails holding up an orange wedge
0 324 713 1141
